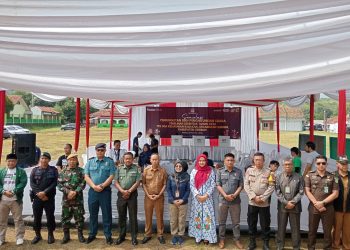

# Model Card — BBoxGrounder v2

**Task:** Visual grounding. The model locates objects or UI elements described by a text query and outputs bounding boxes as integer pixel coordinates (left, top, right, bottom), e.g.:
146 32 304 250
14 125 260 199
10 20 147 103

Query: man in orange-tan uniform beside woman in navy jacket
142 153 168 244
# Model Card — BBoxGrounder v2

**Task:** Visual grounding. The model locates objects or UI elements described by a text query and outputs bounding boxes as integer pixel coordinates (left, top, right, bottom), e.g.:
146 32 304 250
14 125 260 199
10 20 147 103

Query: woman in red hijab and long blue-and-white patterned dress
189 154 217 245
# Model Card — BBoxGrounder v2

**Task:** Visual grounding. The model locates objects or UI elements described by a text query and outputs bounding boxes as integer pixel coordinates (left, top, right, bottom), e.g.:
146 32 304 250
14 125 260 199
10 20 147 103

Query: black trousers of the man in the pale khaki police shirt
248 205 271 241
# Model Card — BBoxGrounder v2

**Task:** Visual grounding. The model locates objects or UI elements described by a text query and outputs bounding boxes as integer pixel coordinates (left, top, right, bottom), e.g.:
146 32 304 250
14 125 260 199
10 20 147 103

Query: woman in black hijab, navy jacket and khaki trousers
167 161 190 245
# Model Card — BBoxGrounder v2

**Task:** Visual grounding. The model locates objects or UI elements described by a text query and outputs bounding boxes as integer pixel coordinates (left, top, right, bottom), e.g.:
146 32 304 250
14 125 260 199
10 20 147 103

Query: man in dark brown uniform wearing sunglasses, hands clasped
305 155 339 250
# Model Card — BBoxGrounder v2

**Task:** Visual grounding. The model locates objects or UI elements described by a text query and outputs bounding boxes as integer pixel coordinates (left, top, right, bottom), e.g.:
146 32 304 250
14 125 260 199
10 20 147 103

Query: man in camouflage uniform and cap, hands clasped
58 154 86 244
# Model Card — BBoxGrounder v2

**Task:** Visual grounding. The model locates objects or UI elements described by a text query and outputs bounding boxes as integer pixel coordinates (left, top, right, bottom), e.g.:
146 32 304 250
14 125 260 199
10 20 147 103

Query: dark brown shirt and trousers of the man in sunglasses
305 171 339 249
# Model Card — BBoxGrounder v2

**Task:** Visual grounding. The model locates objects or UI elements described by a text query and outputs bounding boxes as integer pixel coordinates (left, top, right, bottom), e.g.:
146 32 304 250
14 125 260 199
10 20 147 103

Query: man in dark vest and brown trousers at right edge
332 156 350 249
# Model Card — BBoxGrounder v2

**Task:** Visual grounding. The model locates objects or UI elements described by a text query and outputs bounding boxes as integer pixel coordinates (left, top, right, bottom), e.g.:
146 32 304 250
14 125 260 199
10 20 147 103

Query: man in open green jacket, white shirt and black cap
0 154 27 246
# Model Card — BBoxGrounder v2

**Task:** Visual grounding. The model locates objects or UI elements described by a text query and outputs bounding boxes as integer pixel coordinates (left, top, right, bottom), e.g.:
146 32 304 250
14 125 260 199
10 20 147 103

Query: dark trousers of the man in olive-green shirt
117 191 138 239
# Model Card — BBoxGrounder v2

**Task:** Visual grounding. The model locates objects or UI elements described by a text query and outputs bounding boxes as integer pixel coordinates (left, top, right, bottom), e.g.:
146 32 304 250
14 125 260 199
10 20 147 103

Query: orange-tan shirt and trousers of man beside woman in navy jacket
142 166 168 237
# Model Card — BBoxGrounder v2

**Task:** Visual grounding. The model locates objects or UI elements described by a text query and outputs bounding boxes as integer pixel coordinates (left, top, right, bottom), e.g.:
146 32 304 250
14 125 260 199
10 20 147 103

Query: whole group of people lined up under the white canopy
0 141 350 250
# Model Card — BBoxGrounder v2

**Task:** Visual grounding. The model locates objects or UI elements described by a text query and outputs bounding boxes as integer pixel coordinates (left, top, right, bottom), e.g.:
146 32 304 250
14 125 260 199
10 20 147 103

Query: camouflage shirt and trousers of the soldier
58 167 86 229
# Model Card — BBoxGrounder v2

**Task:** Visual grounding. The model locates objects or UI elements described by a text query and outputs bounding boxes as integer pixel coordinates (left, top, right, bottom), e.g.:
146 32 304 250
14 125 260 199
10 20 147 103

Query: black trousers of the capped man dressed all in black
33 197 56 232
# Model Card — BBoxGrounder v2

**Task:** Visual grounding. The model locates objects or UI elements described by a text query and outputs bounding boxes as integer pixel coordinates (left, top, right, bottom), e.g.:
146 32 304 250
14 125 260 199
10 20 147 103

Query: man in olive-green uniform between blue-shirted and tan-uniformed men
115 152 141 246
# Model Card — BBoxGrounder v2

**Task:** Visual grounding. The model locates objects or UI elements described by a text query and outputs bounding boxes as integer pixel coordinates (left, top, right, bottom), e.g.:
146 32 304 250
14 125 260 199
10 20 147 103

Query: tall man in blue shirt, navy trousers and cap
85 143 115 245
